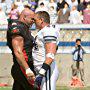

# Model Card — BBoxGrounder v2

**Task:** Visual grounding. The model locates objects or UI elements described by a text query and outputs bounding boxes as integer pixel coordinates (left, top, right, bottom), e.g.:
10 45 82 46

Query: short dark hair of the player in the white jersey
36 11 50 24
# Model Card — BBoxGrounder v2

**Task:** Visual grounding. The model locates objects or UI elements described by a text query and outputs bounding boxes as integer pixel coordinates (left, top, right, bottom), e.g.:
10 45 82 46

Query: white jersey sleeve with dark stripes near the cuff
43 27 59 43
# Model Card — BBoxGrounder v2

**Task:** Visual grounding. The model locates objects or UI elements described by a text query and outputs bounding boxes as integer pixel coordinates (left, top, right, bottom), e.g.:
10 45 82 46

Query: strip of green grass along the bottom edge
0 86 90 90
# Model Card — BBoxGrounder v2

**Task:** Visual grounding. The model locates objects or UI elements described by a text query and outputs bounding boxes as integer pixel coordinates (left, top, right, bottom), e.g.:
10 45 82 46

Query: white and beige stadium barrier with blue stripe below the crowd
0 24 90 53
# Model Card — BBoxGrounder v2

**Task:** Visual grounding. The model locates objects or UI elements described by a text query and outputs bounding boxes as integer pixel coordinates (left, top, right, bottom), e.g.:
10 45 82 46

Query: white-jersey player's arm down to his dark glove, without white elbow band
35 42 56 81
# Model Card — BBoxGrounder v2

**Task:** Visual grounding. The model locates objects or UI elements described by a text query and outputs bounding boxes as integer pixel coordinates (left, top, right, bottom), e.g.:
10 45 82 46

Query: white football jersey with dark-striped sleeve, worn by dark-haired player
32 26 59 71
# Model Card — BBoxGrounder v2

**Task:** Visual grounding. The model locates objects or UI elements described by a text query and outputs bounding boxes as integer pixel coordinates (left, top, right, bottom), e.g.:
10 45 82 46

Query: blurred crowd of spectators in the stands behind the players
0 0 90 25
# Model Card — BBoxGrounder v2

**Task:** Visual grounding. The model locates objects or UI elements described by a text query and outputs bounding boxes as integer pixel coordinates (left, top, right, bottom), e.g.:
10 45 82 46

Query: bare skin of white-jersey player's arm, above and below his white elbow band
45 42 57 65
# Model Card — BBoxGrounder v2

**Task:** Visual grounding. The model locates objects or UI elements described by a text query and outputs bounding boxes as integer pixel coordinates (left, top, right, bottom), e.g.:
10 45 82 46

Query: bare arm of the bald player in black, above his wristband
12 35 29 70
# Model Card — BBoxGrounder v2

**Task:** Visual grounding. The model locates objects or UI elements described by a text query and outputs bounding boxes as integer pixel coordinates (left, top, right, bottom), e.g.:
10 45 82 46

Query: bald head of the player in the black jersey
19 8 34 25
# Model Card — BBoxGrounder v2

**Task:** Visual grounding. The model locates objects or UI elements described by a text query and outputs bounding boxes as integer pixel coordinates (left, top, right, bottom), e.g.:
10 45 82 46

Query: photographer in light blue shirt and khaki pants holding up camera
71 39 85 82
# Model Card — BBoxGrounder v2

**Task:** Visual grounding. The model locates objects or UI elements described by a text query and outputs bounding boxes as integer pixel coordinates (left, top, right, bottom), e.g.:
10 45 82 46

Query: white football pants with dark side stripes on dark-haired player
41 61 59 90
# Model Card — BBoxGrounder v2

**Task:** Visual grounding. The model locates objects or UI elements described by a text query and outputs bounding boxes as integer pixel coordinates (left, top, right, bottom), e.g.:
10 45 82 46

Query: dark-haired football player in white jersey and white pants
32 11 59 90
